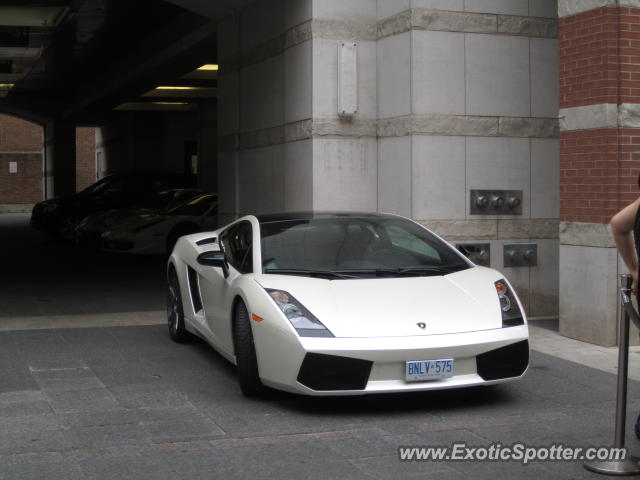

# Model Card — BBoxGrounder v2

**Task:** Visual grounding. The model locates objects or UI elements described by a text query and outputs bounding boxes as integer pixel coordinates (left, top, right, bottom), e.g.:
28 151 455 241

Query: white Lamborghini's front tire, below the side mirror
233 300 264 397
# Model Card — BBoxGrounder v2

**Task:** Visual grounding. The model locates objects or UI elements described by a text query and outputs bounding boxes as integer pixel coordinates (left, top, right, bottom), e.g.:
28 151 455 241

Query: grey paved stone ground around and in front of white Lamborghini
0 216 640 480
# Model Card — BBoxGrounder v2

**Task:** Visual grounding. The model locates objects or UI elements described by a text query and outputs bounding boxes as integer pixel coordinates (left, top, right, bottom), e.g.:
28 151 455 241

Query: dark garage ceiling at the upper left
0 0 240 125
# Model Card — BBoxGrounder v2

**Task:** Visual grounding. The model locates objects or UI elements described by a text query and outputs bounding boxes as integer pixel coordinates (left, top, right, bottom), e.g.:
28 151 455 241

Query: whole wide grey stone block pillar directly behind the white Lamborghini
218 0 559 316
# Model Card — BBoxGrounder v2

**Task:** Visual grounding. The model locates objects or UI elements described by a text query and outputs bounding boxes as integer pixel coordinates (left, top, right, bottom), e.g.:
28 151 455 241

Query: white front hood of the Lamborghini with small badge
256 267 510 337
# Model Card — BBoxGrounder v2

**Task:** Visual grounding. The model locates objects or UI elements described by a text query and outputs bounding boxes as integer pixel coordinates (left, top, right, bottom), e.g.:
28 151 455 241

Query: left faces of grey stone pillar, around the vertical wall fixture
218 0 377 222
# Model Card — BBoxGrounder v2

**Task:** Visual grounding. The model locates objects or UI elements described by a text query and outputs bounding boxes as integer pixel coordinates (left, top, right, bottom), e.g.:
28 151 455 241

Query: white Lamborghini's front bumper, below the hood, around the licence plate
258 325 529 395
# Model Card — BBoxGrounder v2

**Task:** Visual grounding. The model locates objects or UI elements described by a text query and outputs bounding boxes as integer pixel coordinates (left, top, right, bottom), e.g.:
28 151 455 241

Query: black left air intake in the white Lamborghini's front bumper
298 353 373 390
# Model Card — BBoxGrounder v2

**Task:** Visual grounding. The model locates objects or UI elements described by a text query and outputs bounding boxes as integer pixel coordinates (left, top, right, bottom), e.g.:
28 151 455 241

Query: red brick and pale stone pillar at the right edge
559 0 640 346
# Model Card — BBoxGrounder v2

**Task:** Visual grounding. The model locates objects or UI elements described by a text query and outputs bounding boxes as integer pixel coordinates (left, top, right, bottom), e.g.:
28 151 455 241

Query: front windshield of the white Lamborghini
260 216 468 276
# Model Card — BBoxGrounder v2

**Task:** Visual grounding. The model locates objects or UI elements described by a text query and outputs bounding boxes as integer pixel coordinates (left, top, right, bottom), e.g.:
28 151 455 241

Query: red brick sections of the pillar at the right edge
559 7 640 223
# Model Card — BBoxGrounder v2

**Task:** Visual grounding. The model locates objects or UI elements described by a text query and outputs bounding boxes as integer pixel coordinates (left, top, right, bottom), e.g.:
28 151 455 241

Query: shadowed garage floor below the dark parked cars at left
0 214 165 329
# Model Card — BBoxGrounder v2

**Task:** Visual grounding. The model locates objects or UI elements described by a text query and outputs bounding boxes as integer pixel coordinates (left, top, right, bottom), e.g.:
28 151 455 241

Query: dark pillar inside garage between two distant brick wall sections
44 121 76 198
